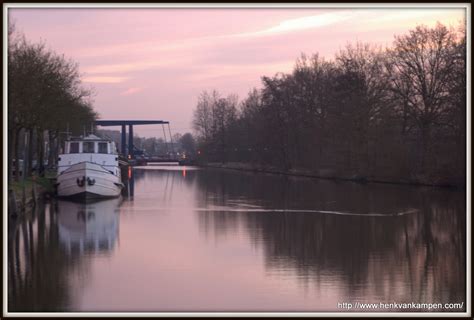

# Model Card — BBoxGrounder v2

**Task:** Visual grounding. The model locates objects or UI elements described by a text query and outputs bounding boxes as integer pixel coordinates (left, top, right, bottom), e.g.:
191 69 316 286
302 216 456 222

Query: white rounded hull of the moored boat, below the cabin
57 162 123 199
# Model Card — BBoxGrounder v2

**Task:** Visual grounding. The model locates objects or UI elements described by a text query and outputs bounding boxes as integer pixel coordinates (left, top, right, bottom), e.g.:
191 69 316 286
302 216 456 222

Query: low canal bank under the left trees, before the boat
8 172 54 215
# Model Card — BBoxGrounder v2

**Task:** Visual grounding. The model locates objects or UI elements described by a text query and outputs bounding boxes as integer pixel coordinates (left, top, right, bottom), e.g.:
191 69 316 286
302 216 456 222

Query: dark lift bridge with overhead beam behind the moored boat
95 120 178 163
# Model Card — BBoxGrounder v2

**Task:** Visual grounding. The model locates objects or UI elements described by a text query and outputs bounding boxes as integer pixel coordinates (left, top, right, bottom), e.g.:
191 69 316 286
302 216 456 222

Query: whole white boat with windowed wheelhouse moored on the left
56 134 124 199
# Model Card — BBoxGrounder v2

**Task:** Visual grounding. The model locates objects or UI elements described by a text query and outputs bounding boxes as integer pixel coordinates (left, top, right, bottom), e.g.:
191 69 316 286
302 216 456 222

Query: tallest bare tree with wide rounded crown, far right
388 24 462 174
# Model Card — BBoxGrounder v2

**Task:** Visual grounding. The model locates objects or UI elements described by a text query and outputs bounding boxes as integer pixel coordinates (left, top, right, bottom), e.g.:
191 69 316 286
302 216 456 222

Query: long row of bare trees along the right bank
193 23 467 185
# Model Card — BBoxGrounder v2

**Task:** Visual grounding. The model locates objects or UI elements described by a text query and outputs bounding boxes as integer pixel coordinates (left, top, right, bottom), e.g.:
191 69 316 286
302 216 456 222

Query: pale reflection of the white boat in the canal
57 197 123 254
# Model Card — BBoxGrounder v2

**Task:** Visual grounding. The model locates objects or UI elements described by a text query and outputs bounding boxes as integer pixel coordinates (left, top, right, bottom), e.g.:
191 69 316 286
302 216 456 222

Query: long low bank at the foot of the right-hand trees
199 162 465 190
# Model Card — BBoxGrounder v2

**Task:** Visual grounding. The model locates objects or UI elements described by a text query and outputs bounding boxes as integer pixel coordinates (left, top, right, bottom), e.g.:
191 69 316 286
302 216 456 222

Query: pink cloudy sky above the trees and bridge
8 7 466 137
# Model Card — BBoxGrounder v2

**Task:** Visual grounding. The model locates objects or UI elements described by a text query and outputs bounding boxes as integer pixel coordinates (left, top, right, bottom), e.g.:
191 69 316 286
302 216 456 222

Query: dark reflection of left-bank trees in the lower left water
8 205 79 312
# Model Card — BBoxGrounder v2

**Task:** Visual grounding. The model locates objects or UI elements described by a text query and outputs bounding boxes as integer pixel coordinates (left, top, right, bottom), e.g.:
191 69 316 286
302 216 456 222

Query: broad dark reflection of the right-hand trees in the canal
193 172 466 311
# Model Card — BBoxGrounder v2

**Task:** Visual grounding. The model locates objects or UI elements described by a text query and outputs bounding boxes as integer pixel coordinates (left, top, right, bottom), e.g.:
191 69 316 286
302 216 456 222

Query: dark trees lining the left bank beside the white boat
8 24 97 180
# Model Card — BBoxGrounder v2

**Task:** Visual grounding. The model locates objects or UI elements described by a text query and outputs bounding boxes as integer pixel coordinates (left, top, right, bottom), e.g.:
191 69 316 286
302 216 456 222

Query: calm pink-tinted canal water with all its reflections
8 166 466 312
